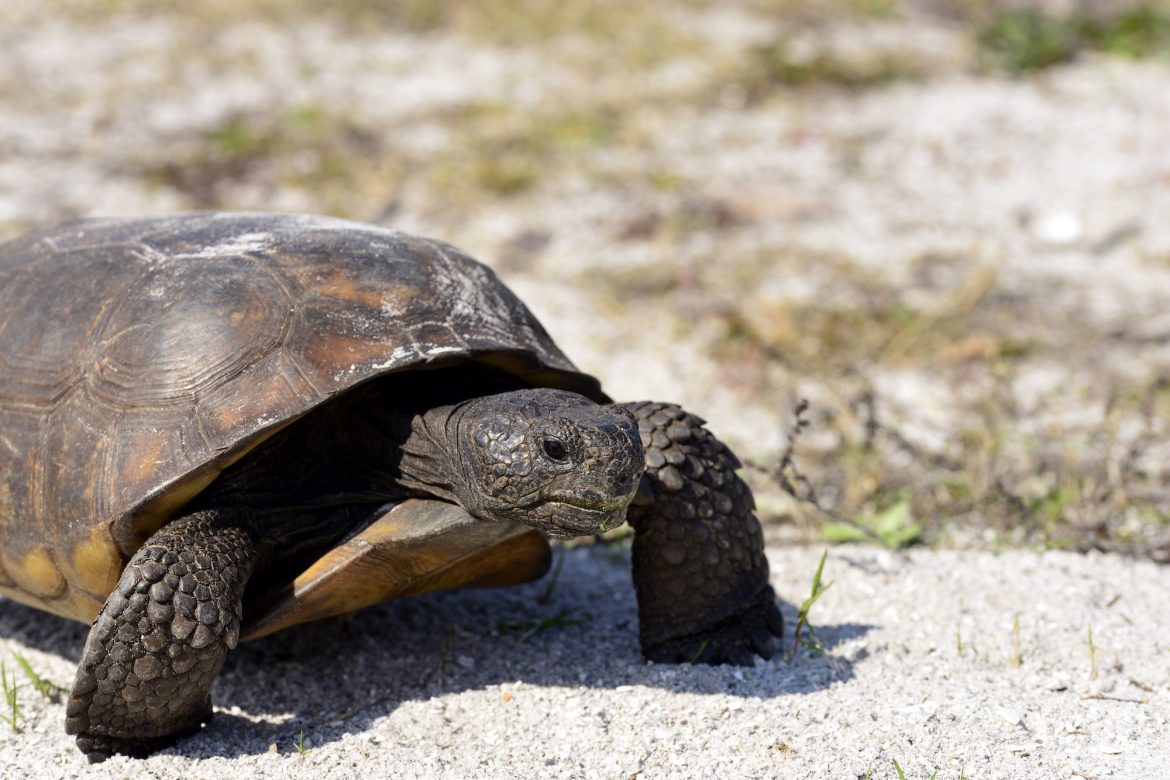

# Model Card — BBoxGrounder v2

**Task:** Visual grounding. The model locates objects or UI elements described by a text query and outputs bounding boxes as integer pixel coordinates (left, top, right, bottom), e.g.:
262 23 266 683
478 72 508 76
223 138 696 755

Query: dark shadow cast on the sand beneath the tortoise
0 548 873 757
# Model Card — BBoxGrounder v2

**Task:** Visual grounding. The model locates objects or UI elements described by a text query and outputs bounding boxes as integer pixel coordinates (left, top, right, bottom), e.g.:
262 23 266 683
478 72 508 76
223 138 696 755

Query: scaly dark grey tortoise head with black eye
456 389 644 538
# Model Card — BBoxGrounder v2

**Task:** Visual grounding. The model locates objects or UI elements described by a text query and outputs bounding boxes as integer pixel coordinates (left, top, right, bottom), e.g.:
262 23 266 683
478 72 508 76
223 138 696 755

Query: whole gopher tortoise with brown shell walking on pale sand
0 213 782 761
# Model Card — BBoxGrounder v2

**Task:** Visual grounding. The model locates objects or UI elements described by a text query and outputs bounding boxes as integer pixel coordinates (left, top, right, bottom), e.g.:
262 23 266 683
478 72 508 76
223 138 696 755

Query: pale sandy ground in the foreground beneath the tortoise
0 546 1170 779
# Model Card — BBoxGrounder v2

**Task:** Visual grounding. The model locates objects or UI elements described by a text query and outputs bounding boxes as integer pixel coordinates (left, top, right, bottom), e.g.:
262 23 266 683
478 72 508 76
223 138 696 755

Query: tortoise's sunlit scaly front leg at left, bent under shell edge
66 511 256 762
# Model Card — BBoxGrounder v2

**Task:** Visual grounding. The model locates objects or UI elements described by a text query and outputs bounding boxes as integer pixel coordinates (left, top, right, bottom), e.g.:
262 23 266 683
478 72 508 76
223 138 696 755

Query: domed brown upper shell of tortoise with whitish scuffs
0 213 607 621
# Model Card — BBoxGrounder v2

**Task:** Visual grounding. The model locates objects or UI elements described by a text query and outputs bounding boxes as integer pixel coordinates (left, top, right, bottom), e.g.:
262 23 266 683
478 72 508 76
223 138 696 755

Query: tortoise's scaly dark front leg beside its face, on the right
621 402 784 665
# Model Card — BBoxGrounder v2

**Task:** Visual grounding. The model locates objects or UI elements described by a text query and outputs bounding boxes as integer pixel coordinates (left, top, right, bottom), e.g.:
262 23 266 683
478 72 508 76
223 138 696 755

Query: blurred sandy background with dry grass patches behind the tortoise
0 0 1170 560
